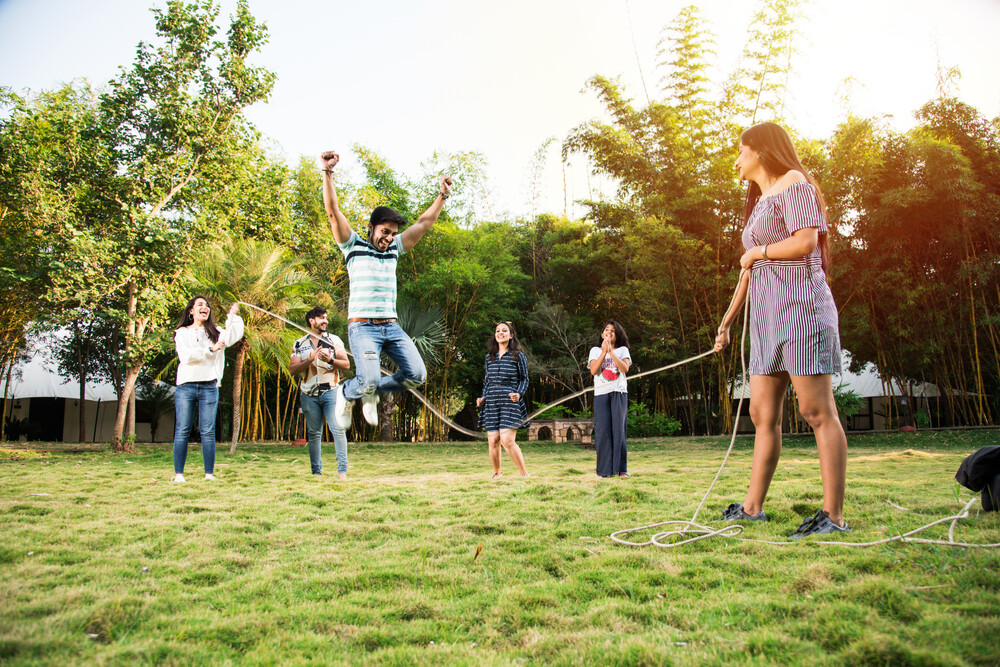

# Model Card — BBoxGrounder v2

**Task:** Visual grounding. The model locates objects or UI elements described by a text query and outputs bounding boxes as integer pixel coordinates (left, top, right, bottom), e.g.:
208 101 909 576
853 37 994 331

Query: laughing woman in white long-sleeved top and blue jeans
174 296 243 482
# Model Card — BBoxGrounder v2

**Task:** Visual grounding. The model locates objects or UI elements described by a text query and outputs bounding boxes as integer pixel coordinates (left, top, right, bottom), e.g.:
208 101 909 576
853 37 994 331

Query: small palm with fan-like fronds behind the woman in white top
188 235 315 453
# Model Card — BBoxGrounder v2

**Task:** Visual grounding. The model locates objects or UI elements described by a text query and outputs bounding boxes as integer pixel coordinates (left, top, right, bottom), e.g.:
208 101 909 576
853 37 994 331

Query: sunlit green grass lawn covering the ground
0 431 1000 665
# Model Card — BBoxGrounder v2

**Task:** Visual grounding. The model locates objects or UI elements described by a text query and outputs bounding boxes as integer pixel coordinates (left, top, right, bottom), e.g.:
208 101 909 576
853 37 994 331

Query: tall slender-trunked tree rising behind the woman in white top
100 0 274 449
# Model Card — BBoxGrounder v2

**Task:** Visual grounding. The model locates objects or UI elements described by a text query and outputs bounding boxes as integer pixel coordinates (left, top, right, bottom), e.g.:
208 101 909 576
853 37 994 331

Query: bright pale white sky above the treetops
0 0 1000 215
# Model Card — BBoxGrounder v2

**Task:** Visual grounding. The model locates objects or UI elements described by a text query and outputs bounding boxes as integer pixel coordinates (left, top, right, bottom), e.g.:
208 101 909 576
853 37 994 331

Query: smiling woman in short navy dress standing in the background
476 322 528 479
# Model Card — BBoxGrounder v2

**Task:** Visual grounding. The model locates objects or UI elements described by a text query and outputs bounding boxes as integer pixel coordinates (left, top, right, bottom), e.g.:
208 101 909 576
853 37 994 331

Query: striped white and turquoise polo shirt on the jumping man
337 230 406 319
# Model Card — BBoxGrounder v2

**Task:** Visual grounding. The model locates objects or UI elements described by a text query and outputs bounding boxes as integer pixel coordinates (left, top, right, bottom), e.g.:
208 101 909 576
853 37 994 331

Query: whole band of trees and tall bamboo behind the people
0 0 1000 448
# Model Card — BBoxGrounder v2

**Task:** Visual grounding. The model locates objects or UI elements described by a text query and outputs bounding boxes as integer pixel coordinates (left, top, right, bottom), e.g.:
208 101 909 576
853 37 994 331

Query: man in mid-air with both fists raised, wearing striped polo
321 151 452 429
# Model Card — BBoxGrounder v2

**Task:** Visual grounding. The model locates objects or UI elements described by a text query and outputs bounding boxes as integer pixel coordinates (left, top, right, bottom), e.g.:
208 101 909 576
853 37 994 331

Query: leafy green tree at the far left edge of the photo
0 85 120 434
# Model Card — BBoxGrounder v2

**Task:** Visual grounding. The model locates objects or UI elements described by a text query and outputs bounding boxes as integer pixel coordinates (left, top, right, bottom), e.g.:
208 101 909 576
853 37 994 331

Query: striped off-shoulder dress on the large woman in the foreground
743 182 840 375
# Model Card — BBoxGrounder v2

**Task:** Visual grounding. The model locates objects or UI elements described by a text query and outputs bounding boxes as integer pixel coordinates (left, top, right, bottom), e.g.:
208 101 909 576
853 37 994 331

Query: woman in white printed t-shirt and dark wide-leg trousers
590 320 632 477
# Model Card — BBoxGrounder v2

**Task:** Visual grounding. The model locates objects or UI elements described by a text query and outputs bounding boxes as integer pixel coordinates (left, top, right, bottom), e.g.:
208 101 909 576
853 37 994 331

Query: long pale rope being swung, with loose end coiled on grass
236 276 1000 549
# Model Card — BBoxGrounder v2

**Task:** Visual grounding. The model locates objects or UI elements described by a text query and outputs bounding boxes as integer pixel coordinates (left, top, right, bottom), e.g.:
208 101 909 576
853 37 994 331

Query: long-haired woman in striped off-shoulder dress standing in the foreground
715 123 850 539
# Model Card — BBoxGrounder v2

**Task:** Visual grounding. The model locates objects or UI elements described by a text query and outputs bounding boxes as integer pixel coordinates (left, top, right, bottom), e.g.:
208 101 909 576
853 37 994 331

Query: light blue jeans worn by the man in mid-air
344 322 427 401
